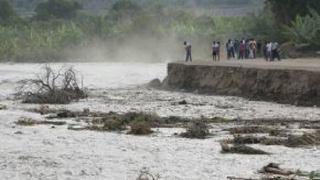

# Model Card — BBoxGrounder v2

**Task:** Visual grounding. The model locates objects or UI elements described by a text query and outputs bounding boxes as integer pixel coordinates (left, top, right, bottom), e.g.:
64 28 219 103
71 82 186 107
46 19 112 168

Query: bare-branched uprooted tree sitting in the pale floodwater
18 65 87 104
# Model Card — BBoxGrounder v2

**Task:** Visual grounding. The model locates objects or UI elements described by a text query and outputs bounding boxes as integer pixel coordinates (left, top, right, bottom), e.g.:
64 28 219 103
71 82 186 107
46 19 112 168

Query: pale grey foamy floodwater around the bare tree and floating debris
0 63 320 180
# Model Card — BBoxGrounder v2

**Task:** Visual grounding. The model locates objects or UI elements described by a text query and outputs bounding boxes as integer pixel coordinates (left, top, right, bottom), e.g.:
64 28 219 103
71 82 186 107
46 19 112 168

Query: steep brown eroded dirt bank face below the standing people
163 63 320 106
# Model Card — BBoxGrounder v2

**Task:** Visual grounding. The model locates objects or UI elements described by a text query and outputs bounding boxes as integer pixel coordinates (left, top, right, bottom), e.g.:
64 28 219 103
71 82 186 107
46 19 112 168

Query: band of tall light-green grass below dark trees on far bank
0 11 254 62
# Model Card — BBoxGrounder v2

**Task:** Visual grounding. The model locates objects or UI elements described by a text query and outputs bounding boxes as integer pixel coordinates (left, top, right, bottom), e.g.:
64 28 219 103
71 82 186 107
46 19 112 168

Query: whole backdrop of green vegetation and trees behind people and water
0 0 320 62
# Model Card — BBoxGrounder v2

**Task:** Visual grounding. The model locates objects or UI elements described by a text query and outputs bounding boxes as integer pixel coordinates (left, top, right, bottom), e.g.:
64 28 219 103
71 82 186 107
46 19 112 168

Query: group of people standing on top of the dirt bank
184 39 280 62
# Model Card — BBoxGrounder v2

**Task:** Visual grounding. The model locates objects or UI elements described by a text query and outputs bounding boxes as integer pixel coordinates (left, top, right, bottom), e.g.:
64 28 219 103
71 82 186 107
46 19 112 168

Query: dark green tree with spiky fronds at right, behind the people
261 0 320 56
